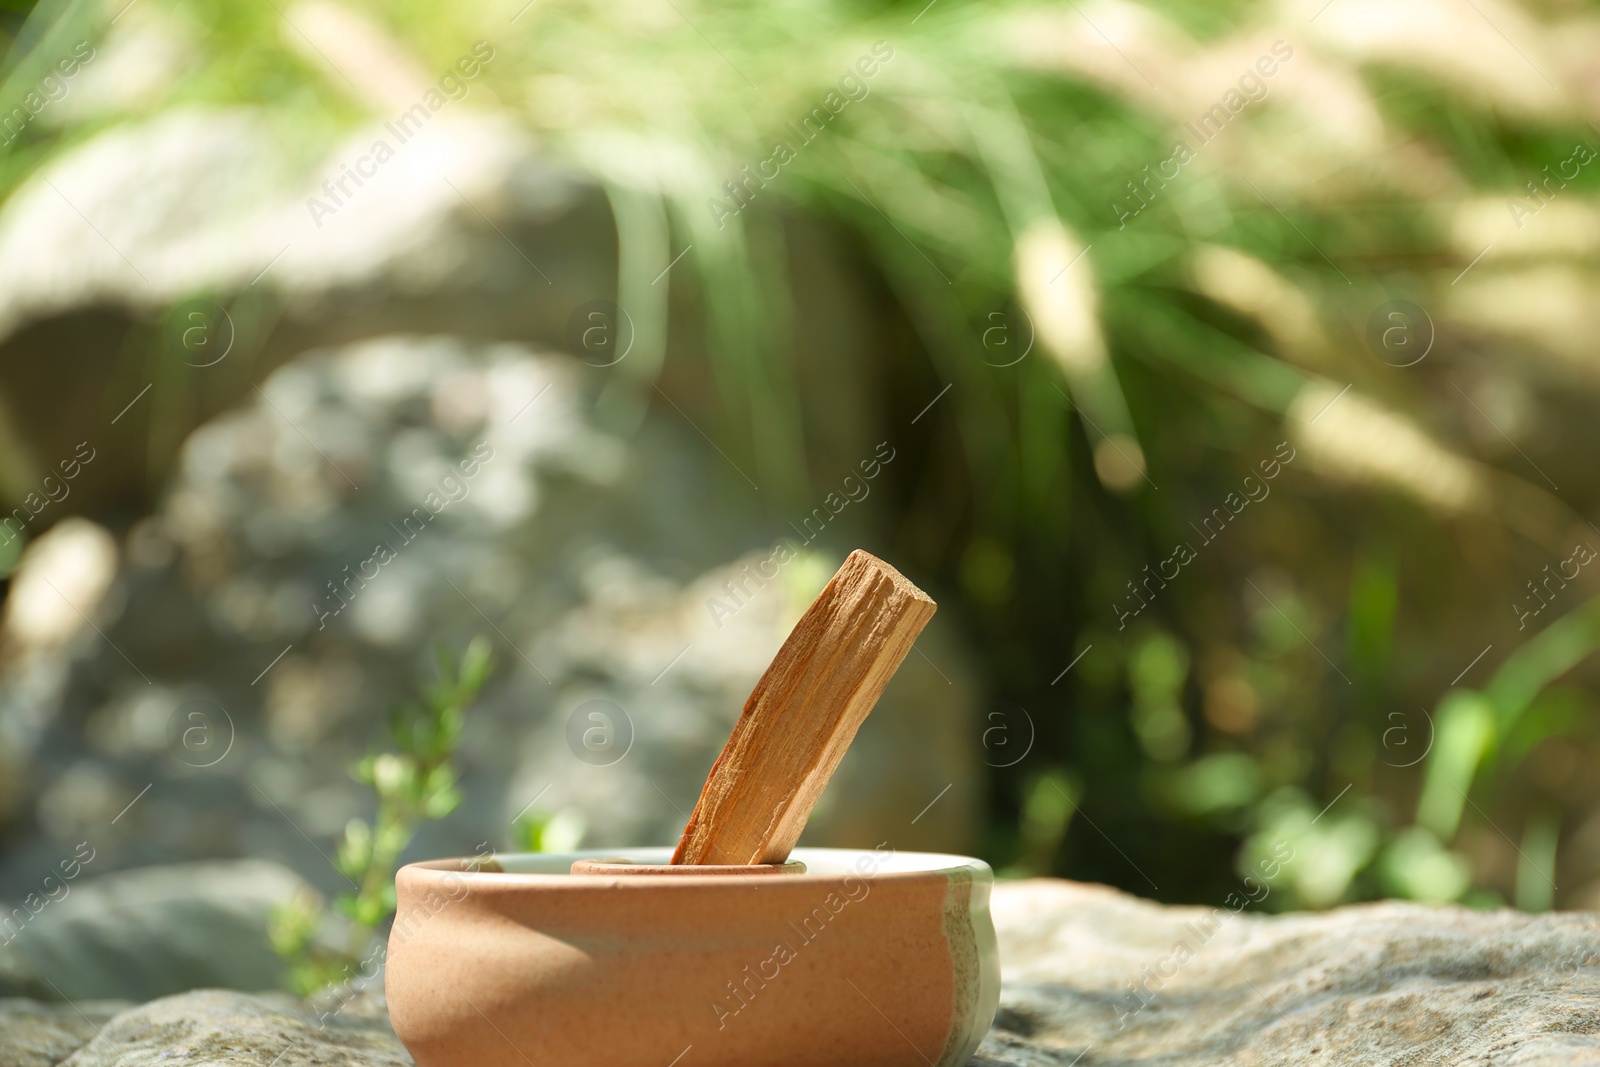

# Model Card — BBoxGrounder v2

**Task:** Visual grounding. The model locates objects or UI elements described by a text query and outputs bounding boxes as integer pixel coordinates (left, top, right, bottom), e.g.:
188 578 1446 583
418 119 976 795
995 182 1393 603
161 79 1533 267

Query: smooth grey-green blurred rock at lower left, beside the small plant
0 849 306 1004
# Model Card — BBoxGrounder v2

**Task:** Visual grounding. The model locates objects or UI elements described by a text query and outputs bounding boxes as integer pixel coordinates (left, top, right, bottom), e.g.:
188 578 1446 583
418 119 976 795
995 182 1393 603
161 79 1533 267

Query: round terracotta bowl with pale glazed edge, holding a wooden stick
386 848 1000 1067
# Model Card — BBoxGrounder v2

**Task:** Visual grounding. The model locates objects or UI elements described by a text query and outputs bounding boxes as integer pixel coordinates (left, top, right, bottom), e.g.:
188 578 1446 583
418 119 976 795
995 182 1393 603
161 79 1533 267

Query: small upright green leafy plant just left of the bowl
270 637 493 995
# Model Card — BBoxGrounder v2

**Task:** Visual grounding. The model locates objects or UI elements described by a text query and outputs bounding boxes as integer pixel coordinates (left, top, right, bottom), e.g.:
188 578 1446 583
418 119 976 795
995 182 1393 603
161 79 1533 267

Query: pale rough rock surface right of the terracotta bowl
979 880 1600 1067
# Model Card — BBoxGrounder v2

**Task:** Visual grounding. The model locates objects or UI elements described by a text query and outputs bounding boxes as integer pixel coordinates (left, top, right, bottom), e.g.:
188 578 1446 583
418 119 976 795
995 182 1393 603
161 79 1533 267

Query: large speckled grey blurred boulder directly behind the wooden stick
0 336 982 894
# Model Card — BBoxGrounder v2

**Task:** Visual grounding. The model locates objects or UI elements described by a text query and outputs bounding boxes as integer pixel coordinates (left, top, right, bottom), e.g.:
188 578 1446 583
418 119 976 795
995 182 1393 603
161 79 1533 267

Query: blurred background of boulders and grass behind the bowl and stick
0 0 1600 997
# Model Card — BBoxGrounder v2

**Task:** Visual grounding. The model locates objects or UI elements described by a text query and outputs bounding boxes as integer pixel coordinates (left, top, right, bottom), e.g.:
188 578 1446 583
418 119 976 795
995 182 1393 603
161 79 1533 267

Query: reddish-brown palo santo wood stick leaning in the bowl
672 549 938 864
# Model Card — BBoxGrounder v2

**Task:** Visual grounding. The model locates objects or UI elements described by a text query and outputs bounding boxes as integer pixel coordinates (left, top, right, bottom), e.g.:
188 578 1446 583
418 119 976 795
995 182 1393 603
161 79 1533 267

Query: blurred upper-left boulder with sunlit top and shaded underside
0 105 614 525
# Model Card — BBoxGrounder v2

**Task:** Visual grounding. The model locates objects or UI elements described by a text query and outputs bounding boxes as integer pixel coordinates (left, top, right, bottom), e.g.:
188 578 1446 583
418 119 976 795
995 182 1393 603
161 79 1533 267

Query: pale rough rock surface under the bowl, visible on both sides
0 880 1600 1067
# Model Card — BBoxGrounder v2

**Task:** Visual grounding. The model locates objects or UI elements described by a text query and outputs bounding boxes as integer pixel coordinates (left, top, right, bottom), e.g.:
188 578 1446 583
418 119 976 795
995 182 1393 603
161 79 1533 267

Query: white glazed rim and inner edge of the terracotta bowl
400 845 994 889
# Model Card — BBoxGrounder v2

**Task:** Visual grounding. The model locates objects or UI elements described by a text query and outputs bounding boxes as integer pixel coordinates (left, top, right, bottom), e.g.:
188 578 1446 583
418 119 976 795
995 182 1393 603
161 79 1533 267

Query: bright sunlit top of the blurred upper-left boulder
0 109 585 338
